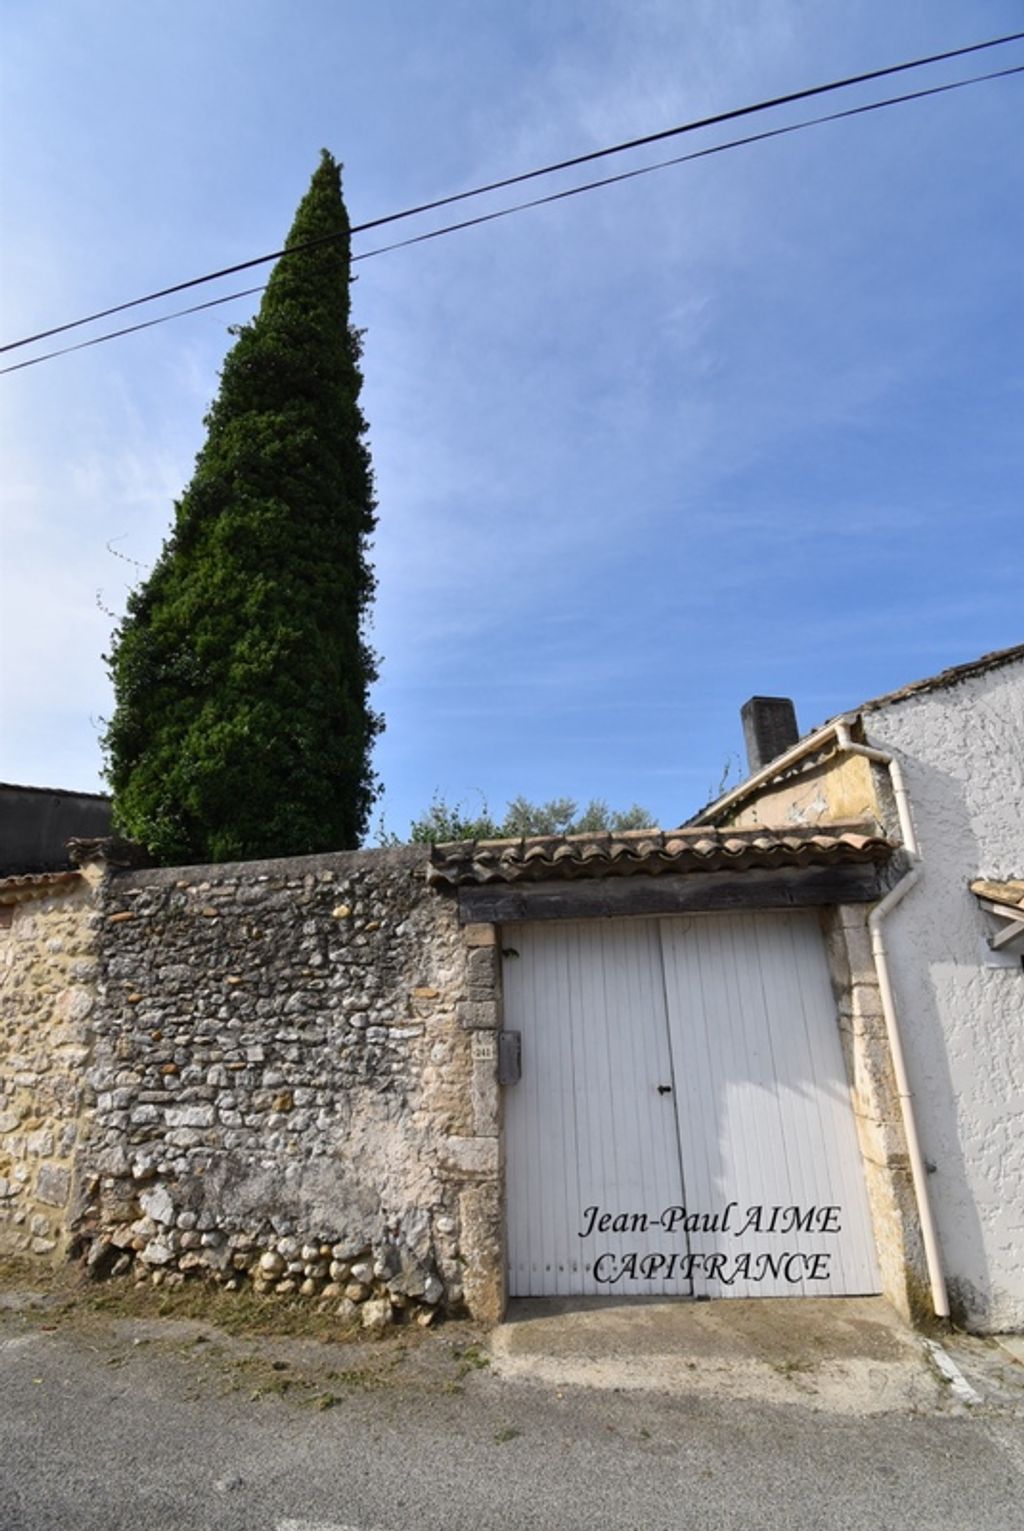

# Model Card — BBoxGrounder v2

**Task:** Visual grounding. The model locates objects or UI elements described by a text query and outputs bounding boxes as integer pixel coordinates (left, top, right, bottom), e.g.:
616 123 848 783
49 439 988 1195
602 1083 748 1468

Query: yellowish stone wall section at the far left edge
0 873 98 1260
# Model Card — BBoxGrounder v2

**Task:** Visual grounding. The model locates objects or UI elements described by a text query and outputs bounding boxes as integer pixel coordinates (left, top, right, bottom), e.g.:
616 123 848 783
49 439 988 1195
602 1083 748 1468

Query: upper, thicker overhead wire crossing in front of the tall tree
0 32 1024 356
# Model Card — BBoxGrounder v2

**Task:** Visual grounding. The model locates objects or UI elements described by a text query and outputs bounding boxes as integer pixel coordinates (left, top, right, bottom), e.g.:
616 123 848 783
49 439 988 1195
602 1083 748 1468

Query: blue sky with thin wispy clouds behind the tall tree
0 0 1024 831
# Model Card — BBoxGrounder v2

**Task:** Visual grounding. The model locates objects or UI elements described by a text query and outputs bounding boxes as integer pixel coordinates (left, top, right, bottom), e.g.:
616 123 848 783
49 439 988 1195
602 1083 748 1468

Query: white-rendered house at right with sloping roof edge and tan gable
693 646 1024 1330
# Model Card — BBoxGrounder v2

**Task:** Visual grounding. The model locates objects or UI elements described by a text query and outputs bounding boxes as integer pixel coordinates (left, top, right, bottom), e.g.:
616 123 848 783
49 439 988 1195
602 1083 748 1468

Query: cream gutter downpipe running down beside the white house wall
834 720 949 1318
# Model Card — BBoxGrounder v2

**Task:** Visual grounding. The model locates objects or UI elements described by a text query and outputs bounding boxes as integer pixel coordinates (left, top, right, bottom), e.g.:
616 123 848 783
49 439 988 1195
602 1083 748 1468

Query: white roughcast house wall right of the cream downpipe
863 660 1024 1332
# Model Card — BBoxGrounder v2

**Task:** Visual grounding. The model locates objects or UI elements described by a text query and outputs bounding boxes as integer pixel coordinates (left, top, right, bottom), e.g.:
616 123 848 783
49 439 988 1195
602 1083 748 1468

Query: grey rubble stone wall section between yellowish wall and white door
71 848 502 1321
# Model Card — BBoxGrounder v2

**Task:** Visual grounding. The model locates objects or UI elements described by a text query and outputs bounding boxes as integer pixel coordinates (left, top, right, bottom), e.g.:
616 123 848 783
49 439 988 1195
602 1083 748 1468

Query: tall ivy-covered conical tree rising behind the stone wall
104 150 383 865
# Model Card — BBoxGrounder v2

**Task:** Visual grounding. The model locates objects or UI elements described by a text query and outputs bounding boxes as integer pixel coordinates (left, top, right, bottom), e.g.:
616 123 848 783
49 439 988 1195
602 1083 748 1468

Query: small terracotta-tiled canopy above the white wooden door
427 822 894 888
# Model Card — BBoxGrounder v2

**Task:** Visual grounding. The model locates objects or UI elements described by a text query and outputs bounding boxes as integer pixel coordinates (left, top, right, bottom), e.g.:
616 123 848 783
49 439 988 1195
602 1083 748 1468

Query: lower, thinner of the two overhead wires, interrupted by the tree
0 64 1024 377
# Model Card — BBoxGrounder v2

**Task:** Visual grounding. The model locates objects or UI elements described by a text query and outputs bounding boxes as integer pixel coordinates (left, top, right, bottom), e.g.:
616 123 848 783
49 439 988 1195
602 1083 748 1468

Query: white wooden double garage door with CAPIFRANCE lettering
502 912 880 1297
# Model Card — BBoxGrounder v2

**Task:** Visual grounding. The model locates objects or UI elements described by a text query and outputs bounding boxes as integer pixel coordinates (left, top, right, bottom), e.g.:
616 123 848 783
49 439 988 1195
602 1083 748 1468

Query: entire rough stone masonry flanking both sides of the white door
0 820 979 1324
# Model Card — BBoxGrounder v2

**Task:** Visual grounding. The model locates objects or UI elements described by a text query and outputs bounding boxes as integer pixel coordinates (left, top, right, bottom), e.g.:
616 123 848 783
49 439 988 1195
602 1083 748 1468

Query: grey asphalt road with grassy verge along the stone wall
0 1314 1024 1531
